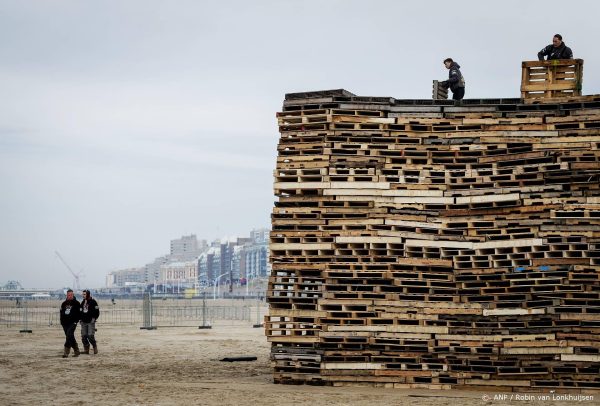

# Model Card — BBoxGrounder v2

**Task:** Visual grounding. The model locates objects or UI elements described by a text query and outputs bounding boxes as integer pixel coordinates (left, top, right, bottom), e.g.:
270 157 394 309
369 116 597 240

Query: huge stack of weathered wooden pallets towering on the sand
265 66 600 392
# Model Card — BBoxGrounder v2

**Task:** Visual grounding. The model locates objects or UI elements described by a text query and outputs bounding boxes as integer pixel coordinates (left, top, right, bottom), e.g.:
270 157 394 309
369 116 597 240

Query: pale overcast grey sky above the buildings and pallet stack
0 0 600 287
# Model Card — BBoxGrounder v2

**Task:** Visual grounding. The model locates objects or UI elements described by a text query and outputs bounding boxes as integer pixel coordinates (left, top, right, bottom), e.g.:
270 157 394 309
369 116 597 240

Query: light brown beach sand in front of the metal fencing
0 321 598 406
